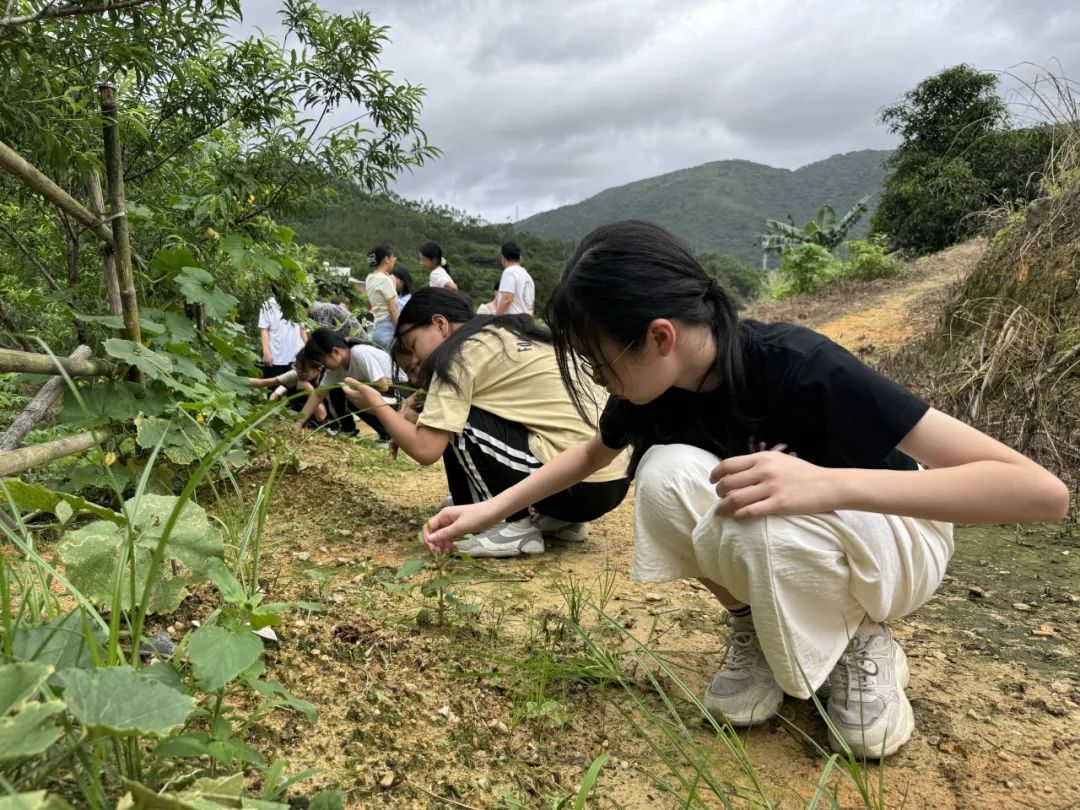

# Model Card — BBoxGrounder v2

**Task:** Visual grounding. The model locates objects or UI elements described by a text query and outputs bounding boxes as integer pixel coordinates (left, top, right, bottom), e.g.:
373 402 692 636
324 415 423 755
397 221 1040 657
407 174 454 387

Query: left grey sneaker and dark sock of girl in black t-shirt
703 616 784 727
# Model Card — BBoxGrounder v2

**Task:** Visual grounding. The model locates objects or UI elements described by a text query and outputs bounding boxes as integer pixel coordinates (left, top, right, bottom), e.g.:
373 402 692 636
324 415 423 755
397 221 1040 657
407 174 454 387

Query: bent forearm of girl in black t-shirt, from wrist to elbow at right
829 460 1068 523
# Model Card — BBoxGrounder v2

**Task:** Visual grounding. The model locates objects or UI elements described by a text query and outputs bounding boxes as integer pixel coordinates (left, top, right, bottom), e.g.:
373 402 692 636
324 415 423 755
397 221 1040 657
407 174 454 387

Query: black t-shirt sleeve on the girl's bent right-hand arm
781 339 930 468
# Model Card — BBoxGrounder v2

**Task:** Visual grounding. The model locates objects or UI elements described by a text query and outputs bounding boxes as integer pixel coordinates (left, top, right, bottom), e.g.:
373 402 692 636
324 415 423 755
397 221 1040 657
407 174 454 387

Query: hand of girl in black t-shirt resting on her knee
708 451 838 521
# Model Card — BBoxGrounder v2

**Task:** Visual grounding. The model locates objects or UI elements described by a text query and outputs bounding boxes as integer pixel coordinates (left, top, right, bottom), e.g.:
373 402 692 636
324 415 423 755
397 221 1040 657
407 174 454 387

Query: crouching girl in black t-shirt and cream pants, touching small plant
424 221 1068 757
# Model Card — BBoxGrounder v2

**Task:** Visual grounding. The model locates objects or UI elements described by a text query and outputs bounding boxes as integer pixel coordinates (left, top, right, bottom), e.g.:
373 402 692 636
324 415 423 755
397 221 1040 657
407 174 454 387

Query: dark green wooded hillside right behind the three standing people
288 189 570 305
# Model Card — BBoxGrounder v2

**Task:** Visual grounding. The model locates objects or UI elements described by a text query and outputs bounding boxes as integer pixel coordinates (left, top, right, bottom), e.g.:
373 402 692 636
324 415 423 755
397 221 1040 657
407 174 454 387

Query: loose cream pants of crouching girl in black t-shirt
631 445 953 698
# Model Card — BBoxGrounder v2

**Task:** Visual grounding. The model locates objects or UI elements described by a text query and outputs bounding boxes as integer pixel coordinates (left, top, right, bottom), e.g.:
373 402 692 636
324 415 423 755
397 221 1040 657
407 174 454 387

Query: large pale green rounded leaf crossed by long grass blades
58 495 224 612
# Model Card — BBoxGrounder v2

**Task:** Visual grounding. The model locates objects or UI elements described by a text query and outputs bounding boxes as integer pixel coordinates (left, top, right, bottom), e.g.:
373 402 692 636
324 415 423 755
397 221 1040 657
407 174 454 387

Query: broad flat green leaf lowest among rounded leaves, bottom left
63 666 195 737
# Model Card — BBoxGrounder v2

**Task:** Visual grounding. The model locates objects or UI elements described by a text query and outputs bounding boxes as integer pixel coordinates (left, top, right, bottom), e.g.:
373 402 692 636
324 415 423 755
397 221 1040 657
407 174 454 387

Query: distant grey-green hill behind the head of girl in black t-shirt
517 149 889 262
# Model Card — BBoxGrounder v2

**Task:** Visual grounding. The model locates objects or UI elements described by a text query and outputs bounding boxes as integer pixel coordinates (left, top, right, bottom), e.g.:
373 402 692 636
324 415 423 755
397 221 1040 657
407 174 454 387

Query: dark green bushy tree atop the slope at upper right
872 65 1052 253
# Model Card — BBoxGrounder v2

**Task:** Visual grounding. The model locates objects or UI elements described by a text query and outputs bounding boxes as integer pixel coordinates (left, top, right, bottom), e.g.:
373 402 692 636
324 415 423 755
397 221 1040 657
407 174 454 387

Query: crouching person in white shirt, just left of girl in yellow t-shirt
296 328 407 441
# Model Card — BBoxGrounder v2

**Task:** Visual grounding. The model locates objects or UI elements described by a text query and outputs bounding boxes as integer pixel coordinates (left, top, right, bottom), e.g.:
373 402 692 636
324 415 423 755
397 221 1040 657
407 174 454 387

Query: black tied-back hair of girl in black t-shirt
544 219 745 443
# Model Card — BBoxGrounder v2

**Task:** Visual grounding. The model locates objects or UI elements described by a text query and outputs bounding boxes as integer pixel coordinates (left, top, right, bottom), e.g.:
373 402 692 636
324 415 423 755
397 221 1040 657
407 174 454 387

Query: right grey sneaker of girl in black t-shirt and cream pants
827 624 915 759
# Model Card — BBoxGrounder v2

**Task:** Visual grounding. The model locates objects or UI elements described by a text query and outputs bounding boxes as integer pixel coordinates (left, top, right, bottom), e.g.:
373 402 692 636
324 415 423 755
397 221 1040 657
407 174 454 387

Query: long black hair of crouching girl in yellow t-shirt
394 287 552 392
